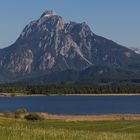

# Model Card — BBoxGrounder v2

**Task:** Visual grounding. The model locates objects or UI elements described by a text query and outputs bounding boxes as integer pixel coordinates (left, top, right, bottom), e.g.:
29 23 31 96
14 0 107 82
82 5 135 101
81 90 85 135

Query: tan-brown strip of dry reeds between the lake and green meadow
0 112 140 122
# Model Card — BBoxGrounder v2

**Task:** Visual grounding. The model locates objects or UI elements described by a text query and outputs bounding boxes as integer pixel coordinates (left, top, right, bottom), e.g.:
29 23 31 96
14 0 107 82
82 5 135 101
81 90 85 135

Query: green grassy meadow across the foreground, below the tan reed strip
0 118 140 140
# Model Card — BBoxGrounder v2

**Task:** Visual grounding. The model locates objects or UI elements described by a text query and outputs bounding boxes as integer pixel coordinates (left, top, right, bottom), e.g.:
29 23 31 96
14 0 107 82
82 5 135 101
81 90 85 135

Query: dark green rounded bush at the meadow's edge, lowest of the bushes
24 113 43 121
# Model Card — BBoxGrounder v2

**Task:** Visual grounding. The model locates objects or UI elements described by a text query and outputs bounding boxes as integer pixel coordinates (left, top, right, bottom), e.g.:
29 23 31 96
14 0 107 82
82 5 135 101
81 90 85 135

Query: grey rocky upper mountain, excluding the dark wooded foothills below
0 11 140 83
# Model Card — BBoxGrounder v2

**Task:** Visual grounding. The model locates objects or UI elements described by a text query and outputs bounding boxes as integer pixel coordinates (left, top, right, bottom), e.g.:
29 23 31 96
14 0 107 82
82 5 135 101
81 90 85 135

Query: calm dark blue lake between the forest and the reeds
0 96 140 114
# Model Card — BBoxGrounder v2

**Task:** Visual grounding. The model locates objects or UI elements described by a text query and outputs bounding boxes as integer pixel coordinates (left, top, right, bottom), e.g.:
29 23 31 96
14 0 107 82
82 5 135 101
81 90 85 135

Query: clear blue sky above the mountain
0 0 140 48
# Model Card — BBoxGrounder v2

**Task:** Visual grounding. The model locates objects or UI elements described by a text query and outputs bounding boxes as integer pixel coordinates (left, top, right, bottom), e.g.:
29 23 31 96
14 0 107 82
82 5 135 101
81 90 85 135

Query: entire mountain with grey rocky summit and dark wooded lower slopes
0 11 140 83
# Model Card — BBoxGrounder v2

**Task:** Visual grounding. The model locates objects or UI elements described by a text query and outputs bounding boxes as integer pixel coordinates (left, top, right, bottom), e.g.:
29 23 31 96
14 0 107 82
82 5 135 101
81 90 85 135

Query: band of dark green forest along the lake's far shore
0 83 140 95
